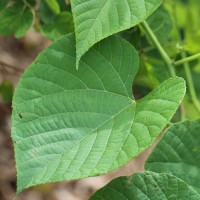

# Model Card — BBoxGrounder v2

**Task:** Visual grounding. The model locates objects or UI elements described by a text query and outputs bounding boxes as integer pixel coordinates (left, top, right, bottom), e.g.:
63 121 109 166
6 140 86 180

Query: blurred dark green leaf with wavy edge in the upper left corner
0 5 33 38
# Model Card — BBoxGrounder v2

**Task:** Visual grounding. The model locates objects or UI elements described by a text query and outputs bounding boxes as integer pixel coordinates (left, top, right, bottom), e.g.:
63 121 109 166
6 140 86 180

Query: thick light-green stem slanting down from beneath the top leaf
143 21 176 77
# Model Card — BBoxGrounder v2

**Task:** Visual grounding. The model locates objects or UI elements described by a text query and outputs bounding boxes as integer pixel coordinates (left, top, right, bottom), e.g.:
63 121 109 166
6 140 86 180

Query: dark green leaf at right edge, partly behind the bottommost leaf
146 120 200 192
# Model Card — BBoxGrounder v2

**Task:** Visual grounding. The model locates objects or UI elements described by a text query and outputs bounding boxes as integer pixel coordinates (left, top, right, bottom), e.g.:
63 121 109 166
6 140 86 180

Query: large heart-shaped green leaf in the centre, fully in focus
12 35 185 192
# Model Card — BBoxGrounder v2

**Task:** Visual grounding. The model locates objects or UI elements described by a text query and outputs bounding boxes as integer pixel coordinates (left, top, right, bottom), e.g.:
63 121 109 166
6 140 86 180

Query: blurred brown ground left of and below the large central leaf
0 30 150 200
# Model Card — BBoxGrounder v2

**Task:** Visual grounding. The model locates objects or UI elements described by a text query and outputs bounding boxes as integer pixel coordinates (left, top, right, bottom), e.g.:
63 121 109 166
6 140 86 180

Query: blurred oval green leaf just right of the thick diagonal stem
147 8 172 43
